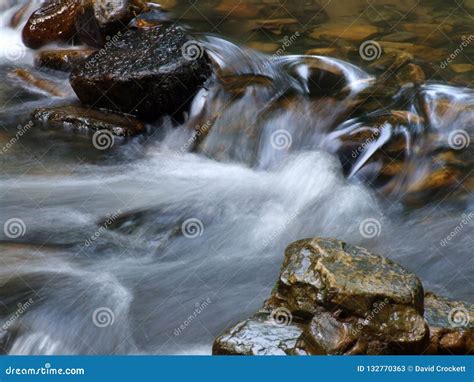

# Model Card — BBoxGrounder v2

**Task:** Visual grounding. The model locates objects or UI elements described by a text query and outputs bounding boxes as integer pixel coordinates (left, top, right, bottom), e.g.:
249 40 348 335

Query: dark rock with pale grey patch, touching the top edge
75 0 143 48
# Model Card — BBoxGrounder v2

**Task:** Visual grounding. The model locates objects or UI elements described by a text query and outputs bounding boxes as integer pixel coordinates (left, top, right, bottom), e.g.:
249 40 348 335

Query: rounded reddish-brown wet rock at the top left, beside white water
22 0 81 49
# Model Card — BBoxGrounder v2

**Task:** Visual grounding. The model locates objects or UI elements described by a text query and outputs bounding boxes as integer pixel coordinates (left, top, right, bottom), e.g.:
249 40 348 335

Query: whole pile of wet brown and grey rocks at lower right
213 239 474 355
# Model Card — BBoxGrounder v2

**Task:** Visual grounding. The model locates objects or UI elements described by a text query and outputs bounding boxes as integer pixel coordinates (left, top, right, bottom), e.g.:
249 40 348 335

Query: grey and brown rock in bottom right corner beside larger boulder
425 293 474 354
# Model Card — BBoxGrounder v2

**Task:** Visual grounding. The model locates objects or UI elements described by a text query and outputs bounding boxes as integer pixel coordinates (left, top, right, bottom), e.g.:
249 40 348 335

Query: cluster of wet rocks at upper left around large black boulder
23 0 211 135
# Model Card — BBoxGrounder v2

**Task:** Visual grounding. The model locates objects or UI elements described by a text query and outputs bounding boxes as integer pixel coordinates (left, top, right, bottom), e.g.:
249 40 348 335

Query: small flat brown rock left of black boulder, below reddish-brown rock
35 48 95 72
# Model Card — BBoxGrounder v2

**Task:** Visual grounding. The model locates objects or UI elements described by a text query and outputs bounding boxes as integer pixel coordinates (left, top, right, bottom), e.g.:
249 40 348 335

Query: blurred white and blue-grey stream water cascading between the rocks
0 1 474 354
